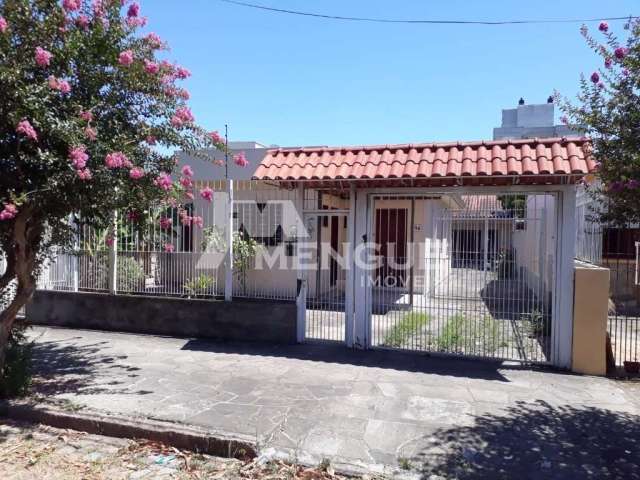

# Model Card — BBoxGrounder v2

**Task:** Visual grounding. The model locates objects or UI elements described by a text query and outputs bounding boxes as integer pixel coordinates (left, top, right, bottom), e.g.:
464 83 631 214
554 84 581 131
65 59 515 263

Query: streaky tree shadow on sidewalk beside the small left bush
32 337 151 396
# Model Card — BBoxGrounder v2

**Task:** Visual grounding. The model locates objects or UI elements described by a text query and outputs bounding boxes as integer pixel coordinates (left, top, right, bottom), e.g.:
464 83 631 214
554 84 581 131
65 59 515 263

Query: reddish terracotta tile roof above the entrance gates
254 137 595 183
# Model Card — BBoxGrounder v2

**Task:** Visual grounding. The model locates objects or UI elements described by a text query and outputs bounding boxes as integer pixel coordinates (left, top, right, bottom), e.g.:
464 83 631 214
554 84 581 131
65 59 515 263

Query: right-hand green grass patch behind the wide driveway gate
436 313 500 356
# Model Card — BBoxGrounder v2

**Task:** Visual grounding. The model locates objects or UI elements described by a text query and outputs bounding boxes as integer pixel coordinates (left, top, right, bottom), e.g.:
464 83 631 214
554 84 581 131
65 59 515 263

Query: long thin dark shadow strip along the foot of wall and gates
182 340 531 382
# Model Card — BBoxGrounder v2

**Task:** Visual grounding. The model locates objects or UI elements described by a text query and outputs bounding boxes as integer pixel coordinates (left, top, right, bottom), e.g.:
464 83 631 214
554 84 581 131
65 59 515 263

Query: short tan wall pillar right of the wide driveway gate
571 262 609 375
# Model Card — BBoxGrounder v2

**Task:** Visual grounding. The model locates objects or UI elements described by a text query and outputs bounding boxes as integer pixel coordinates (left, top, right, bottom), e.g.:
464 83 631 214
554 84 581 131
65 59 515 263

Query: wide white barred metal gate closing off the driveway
368 192 558 363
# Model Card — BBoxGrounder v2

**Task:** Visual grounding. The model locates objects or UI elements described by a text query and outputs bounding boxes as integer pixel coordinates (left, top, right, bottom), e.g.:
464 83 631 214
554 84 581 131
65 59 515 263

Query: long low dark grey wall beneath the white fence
27 291 296 344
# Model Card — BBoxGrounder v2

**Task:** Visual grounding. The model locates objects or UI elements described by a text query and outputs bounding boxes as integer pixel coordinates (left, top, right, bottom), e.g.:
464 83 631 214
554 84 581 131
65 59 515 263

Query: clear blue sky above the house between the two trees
140 0 640 146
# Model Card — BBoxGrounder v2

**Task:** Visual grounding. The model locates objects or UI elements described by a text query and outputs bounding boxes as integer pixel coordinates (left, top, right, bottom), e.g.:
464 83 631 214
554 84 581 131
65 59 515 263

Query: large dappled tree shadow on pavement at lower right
414 401 640 480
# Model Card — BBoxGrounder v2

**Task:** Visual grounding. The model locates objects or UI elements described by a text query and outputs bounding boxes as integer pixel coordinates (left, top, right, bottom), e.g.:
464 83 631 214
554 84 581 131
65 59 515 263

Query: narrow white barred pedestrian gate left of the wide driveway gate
298 212 348 342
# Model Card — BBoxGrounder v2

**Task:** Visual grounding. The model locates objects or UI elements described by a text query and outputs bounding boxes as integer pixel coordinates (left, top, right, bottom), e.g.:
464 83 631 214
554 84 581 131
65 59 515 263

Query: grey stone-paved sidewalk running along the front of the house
26 328 640 479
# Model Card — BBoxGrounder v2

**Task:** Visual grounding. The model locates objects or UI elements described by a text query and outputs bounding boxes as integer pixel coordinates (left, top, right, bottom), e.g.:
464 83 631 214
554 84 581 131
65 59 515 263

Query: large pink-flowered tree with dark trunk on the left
0 0 230 374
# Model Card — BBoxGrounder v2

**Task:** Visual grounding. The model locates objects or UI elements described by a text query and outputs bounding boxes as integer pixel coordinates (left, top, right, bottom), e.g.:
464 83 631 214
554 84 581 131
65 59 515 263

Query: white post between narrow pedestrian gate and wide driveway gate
352 191 371 348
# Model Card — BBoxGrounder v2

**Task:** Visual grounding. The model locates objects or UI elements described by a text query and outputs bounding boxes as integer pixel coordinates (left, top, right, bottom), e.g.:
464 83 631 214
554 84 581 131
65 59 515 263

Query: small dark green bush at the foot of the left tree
0 321 33 398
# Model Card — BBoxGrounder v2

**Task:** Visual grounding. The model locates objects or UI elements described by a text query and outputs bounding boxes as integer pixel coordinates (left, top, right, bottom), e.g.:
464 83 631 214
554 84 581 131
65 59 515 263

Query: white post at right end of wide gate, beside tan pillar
551 185 576 368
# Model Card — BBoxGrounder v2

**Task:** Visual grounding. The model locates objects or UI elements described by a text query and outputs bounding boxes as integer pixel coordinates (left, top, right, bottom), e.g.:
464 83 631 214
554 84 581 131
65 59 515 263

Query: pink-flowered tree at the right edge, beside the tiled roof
560 19 640 225
